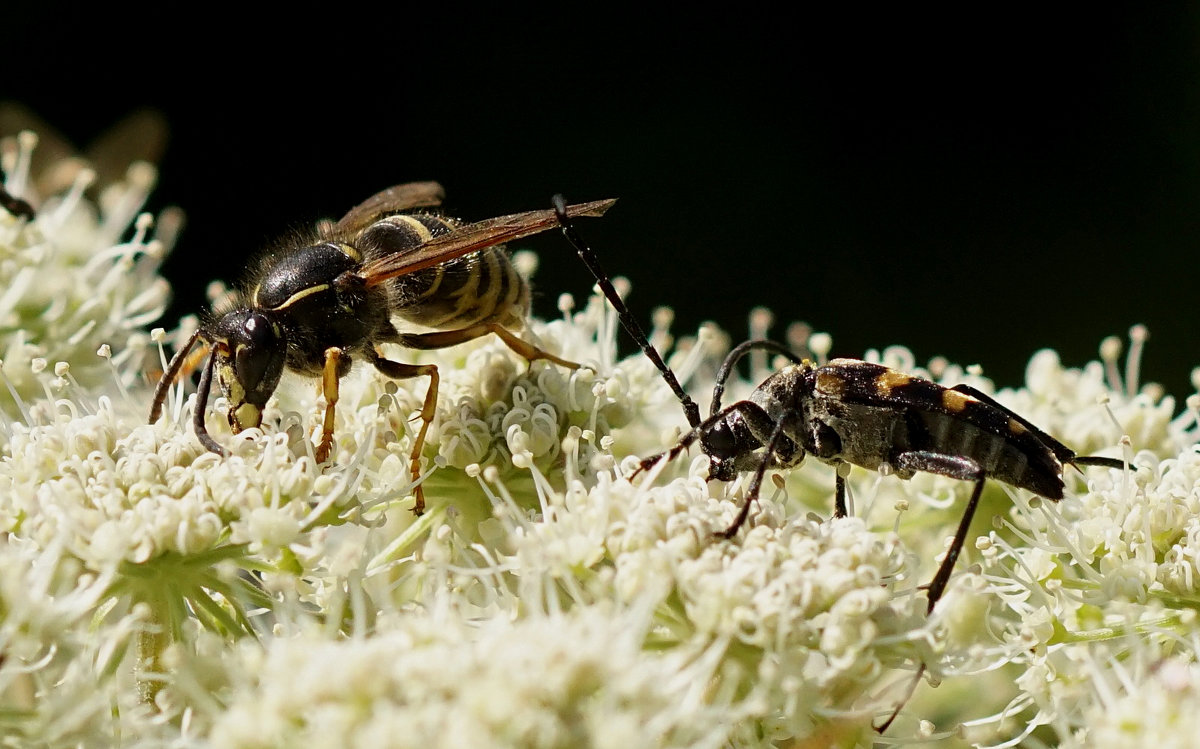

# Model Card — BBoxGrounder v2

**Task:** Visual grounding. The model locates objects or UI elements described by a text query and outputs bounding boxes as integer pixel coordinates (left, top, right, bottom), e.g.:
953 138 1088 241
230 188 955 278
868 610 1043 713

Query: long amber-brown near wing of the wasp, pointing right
358 198 617 286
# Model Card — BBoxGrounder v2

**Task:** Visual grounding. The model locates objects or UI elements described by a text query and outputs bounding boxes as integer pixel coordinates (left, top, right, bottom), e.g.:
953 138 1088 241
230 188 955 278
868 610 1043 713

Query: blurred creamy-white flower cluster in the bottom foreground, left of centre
210 609 742 749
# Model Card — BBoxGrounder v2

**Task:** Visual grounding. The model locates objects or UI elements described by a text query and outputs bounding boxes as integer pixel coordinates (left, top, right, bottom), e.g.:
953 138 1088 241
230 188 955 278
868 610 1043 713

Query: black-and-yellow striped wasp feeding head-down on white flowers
150 182 616 514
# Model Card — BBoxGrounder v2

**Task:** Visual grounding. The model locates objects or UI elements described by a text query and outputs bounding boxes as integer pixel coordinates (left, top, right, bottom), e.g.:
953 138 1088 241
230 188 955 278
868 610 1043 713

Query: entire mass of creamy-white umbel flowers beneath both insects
0 118 1200 747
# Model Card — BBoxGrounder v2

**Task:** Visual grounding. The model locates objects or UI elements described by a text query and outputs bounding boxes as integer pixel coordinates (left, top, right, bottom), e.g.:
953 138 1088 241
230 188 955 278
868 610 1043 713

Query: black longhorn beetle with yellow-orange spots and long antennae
553 196 1124 732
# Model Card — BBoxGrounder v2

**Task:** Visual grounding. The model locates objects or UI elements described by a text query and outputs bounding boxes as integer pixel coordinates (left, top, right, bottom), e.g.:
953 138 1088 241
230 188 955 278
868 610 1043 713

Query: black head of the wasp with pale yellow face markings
214 310 287 432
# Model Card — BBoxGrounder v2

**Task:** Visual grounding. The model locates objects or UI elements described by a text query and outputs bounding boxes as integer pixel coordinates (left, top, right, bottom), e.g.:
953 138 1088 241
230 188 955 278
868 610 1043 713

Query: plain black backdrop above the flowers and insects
9 5 1200 396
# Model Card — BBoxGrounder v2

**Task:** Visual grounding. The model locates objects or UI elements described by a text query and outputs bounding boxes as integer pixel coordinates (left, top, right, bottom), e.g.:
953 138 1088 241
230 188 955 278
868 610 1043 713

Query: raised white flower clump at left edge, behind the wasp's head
0 132 180 410
